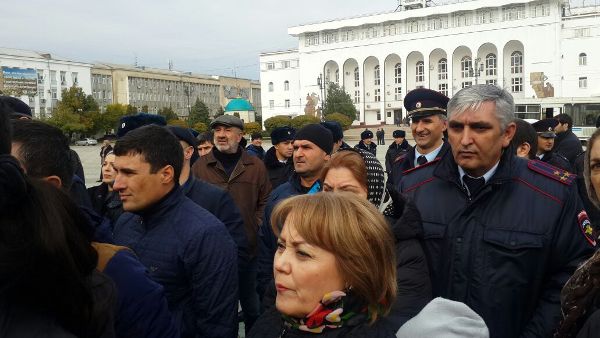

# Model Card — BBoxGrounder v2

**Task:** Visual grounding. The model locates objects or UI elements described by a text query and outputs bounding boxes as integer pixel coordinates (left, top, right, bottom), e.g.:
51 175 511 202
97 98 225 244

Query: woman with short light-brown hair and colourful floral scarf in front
249 192 396 338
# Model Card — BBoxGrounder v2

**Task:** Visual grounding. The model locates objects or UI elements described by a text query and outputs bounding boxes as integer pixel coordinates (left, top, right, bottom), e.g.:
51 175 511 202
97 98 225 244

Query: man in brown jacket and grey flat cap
192 115 271 332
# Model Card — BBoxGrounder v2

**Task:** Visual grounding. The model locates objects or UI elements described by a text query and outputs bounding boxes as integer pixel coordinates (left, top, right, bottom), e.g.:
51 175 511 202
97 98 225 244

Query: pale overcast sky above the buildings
0 0 397 79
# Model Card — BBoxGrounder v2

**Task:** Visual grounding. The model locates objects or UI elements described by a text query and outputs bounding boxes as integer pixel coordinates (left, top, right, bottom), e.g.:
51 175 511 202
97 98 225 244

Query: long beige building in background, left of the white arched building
92 63 261 118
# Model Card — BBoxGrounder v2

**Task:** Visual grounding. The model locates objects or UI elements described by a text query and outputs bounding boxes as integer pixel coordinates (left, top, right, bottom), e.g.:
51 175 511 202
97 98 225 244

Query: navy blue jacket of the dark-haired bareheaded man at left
114 186 238 337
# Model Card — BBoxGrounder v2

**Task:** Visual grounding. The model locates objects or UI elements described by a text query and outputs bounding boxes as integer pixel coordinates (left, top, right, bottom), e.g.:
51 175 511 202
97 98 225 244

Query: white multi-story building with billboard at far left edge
0 48 92 118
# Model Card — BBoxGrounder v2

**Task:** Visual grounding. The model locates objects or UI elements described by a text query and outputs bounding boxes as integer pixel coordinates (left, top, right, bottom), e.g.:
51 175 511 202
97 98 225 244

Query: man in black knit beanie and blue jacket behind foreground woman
256 124 333 298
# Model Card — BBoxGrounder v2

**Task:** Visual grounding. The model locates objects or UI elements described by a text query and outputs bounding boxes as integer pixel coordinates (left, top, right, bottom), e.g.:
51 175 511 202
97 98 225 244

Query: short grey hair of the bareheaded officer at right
448 84 515 130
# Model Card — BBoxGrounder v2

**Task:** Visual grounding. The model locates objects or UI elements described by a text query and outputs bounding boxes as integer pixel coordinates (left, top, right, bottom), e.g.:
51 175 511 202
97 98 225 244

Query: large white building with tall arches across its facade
260 0 600 125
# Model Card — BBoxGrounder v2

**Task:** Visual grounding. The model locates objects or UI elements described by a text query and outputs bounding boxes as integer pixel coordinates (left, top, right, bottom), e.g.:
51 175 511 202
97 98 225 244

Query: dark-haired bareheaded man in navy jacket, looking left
113 125 238 337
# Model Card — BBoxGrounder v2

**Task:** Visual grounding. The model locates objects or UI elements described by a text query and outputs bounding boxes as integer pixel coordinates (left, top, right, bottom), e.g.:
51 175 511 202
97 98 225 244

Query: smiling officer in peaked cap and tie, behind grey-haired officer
388 88 449 189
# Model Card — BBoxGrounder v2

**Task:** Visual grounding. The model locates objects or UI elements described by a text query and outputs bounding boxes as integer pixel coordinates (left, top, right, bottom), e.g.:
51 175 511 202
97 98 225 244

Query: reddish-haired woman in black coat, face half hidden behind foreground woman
321 149 432 330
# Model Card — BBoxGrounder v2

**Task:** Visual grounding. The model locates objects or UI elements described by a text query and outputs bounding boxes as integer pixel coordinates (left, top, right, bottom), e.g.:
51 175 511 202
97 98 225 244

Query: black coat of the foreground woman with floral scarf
247 308 396 338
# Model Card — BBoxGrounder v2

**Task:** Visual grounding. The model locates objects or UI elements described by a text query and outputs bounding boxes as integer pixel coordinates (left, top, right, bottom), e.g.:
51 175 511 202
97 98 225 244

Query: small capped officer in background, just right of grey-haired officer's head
532 119 573 172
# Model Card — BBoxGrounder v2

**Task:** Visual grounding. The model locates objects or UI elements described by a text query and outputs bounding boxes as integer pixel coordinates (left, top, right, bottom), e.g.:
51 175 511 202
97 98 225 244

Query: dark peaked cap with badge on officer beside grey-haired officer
404 88 450 118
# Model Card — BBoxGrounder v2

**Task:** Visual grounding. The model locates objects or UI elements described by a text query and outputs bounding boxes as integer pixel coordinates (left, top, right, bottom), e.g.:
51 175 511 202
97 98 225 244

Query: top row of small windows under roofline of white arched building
304 2 550 46
